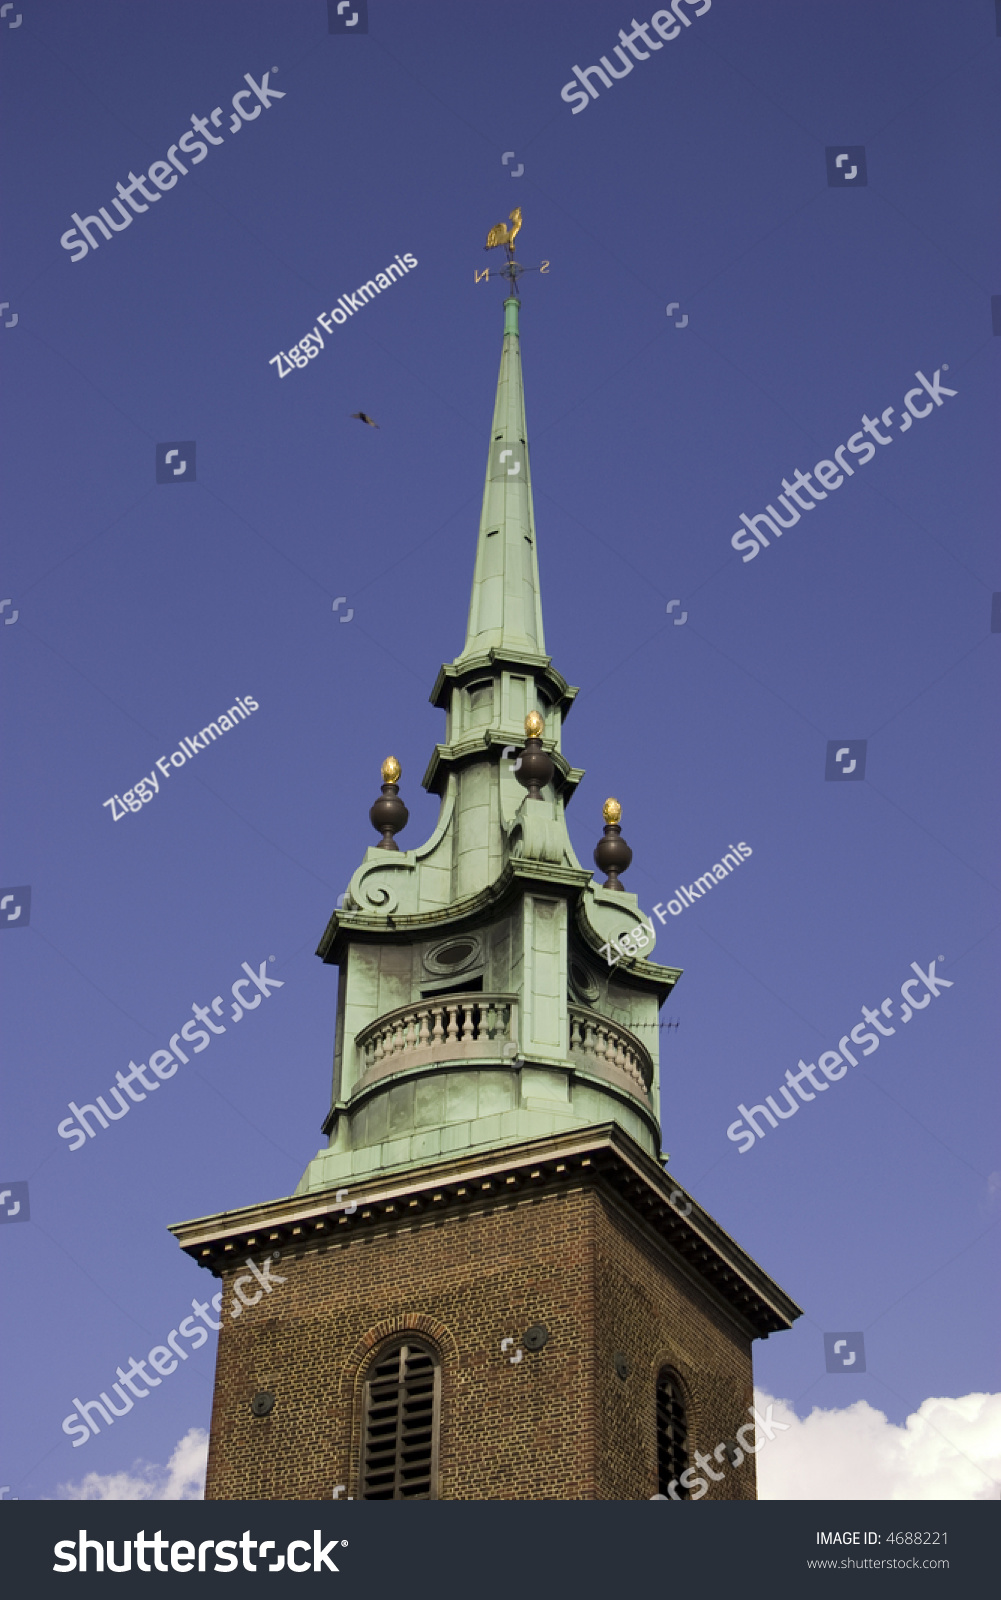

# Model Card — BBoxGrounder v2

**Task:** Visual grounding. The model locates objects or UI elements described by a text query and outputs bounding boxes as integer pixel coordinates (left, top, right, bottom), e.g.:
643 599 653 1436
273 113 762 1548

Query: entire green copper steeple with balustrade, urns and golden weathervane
292 268 680 1194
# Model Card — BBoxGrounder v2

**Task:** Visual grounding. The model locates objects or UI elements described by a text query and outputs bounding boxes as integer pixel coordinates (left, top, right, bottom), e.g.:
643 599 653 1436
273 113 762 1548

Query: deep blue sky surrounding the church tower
0 0 1001 1499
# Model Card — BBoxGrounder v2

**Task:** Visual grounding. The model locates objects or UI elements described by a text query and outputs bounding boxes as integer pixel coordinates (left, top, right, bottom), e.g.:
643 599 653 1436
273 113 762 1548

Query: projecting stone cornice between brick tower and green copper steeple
169 1123 801 1338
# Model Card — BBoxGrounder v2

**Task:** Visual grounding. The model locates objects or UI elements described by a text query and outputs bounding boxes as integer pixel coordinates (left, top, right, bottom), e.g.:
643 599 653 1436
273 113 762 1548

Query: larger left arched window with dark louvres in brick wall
361 1341 440 1499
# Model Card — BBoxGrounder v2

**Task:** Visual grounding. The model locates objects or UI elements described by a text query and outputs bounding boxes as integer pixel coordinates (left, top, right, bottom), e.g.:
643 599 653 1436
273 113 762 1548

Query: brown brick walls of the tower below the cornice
205 1174 755 1499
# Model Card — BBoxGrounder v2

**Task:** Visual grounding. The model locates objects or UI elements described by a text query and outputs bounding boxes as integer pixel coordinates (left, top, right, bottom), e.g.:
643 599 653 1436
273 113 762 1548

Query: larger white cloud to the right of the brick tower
755 1390 1001 1501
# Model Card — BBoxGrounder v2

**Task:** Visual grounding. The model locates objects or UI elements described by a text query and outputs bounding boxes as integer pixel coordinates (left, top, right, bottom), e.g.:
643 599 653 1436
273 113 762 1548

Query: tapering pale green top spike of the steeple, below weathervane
456 296 545 666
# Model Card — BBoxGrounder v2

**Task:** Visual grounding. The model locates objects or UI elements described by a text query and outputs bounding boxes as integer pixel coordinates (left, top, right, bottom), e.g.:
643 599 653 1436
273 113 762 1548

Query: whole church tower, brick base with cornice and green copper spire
171 259 800 1499
